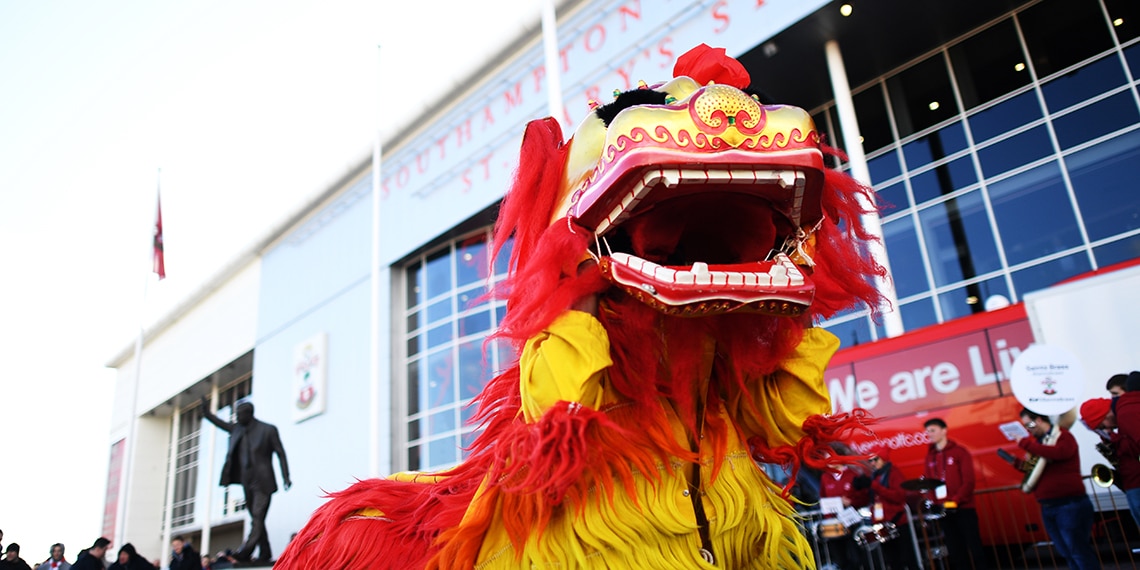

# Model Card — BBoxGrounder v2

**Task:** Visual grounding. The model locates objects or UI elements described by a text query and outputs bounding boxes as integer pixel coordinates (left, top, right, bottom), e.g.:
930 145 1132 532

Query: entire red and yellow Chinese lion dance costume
278 46 885 569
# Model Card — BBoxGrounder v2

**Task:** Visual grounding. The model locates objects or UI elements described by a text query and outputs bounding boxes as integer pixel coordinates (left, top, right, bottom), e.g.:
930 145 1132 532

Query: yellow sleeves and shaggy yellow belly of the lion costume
458 311 839 570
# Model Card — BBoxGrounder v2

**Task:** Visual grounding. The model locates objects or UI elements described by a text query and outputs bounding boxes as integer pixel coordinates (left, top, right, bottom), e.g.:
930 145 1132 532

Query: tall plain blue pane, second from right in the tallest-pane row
990 162 1081 264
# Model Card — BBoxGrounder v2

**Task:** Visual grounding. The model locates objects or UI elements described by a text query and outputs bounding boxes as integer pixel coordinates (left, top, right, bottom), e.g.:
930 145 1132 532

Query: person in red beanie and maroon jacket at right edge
1081 392 1140 526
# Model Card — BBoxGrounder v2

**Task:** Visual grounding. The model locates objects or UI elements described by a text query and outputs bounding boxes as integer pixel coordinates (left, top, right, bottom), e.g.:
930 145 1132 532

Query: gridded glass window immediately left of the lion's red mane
397 227 512 471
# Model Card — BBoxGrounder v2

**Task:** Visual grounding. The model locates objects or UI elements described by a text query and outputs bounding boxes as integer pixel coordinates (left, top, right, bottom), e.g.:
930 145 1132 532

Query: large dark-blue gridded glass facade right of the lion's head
813 0 1140 347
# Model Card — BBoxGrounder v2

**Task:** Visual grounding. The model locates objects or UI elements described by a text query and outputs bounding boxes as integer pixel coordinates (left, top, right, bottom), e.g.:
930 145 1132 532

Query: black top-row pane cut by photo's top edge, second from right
1017 0 1113 78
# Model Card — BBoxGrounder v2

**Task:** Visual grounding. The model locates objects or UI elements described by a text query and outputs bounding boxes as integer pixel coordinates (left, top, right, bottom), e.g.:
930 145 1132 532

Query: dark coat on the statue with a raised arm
206 414 290 492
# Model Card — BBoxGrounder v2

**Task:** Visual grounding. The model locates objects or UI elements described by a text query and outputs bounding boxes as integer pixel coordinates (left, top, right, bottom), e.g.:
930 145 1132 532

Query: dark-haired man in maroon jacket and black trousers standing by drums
922 417 990 570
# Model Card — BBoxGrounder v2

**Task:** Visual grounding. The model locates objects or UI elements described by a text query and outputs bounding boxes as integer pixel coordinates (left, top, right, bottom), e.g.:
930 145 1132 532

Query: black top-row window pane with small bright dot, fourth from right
884 54 958 137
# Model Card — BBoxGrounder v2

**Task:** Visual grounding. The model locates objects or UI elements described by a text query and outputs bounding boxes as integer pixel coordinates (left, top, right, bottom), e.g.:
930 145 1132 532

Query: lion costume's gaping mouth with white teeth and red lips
581 164 817 316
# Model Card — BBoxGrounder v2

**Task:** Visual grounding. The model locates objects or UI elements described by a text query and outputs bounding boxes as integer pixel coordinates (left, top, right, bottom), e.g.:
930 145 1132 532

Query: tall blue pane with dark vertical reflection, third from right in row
919 190 1001 286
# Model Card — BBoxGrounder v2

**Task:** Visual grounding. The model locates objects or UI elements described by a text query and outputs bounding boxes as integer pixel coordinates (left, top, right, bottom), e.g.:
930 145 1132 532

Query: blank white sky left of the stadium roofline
0 0 538 563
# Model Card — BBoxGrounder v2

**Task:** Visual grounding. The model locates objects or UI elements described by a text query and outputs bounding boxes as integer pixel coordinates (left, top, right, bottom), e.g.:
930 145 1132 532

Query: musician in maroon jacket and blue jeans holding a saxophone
1017 408 1100 570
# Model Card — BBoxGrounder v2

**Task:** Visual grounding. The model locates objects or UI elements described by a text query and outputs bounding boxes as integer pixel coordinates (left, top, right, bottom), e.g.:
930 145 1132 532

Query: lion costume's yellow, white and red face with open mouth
564 78 823 315
